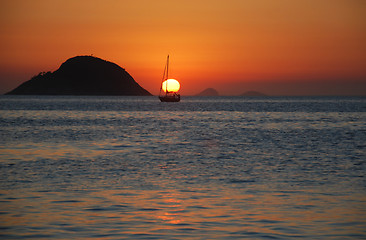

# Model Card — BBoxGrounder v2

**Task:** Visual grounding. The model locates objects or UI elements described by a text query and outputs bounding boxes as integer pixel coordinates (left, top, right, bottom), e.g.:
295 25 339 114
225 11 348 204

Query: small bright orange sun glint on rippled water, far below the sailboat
157 194 183 224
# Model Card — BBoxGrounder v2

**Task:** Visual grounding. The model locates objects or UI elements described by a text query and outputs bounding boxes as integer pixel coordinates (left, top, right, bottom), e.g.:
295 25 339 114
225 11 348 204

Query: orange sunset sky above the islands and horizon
0 0 366 95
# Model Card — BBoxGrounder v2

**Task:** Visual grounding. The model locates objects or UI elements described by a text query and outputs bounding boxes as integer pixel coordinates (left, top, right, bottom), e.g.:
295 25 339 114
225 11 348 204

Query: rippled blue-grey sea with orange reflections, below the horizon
0 96 366 239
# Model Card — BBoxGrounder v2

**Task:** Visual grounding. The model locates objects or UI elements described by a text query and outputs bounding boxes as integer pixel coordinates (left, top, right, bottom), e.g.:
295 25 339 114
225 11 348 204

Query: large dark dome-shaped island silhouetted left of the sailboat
7 56 151 96
